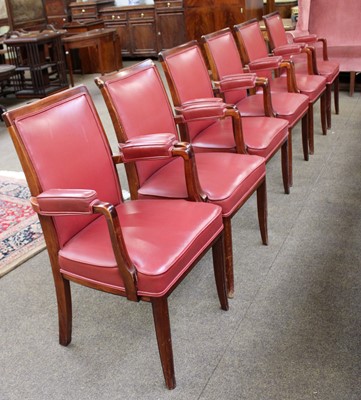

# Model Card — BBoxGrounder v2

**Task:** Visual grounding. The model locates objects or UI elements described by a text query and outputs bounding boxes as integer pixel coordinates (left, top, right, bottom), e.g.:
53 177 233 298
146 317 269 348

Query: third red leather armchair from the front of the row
159 41 290 193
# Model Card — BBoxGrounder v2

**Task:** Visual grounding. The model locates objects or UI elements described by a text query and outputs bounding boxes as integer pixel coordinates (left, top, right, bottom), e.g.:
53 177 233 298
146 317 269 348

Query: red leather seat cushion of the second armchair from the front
139 153 266 217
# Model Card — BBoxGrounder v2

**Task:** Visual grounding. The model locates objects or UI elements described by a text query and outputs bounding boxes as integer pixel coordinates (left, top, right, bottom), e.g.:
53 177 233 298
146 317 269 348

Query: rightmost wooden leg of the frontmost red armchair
212 234 229 311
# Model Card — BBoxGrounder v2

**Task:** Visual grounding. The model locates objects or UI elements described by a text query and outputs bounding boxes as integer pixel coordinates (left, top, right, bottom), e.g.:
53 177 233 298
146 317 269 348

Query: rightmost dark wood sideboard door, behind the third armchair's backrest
156 11 186 51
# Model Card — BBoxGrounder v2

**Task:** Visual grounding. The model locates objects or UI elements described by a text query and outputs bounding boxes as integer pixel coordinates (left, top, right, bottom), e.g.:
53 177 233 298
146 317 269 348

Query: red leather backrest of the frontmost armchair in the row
15 93 121 246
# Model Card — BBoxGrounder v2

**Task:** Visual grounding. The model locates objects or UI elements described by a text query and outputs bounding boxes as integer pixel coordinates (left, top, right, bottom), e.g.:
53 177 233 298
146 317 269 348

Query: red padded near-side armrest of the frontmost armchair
31 189 98 216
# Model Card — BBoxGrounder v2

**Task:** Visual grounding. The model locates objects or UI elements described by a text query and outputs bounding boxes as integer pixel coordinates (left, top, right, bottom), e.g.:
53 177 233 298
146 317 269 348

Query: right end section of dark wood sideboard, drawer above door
154 0 186 51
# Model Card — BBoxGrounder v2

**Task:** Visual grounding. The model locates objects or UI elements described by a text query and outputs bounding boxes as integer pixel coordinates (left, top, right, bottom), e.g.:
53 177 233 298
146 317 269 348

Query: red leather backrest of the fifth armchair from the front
237 21 272 78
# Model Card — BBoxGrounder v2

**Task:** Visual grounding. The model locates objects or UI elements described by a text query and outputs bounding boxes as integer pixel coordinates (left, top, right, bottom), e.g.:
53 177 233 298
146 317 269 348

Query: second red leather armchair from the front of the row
96 60 268 297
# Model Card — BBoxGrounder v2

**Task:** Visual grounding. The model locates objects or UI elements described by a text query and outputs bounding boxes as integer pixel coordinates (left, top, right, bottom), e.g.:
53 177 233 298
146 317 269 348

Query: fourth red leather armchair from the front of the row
202 28 308 185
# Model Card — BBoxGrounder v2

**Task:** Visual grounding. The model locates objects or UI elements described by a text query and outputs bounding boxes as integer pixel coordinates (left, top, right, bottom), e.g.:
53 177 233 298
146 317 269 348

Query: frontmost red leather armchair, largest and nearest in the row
4 86 228 389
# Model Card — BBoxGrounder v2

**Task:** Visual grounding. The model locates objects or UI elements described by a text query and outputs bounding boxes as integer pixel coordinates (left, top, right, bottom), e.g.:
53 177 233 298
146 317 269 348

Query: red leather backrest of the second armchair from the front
105 64 178 185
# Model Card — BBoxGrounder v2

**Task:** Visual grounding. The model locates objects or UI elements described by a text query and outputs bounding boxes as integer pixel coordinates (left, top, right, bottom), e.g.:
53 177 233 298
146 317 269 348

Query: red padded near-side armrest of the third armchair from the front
175 98 227 122
